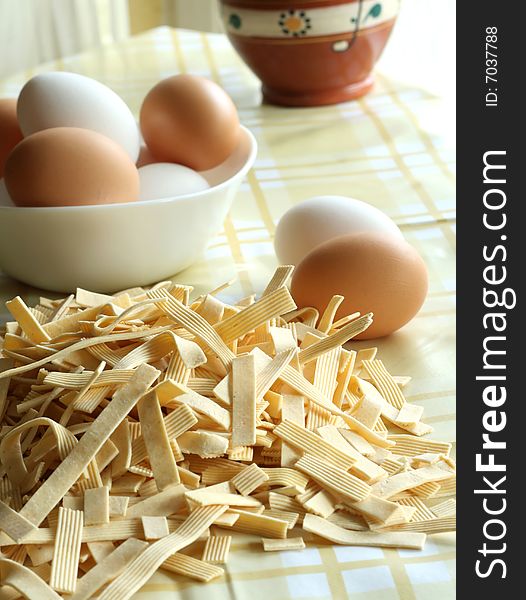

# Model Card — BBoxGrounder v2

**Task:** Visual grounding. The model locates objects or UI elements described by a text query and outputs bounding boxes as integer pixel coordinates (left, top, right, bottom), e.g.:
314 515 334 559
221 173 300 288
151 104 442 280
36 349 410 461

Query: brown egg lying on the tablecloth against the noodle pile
291 232 427 340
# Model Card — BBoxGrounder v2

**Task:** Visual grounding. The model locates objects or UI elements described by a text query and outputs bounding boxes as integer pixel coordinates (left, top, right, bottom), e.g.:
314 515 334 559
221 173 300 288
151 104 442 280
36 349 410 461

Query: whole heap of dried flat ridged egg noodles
0 266 456 600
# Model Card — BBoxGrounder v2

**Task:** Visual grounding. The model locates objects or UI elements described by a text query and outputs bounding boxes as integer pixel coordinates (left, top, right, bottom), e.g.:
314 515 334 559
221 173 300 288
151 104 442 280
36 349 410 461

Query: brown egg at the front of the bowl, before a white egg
5 127 139 206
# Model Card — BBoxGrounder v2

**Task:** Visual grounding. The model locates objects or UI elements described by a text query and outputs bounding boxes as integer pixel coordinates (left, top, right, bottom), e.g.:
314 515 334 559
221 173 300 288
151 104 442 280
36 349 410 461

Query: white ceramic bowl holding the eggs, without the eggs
0 127 257 292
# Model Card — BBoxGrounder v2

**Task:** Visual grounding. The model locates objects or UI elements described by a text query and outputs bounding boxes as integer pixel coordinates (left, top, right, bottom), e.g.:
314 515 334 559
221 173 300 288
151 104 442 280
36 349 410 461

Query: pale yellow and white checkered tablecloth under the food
0 28 455 600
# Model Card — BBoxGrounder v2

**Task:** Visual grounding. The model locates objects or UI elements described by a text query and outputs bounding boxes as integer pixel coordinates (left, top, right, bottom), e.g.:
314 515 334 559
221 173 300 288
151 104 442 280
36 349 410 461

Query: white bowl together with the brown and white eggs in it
0 72 257 292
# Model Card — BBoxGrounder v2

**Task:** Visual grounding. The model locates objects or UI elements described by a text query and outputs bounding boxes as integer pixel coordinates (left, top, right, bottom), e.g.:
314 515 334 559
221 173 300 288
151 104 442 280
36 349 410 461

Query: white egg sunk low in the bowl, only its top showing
139 163 210 200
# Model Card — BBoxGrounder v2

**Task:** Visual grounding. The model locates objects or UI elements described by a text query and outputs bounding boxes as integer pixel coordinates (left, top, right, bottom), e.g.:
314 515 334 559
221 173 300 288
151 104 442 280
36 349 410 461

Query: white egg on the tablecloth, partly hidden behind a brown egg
274 196 403 265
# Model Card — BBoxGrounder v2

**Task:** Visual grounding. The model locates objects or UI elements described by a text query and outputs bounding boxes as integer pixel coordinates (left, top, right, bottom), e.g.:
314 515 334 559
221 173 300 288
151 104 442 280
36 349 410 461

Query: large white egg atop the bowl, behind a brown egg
17 71 140 162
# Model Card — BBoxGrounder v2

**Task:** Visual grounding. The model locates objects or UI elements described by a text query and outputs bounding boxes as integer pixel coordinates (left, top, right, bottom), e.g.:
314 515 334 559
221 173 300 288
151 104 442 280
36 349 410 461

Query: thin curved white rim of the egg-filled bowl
0 124 258 213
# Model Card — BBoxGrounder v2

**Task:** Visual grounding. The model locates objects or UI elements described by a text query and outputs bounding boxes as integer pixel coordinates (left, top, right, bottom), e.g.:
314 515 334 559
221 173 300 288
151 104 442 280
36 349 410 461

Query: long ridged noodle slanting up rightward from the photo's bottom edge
99 506 226 600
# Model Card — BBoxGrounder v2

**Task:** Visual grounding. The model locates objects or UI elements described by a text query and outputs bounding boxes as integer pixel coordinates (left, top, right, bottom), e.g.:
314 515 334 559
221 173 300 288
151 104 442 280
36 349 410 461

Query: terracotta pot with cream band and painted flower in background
220 0 400 106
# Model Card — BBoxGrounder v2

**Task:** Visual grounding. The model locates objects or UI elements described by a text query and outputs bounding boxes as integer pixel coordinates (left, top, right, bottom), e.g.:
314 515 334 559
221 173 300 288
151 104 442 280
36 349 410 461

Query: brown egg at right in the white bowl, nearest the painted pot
140 75 239 171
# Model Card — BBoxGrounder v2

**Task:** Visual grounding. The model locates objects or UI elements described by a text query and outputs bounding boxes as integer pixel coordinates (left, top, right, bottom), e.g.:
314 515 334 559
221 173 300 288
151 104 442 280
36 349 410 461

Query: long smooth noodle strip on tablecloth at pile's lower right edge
303 514 426 550
